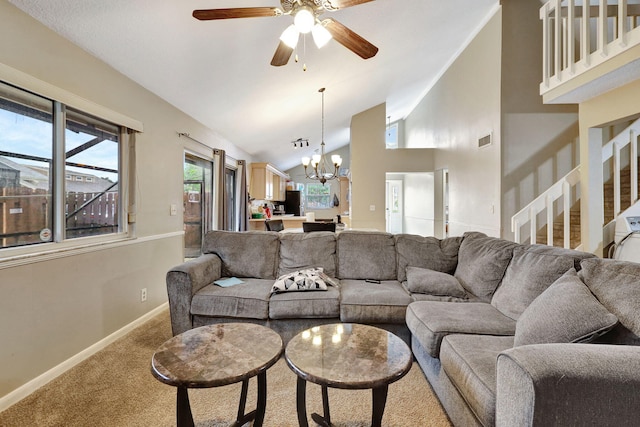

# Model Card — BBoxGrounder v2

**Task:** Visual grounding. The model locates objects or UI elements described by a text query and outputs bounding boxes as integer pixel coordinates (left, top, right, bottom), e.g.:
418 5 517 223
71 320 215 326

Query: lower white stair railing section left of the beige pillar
511 166 580 248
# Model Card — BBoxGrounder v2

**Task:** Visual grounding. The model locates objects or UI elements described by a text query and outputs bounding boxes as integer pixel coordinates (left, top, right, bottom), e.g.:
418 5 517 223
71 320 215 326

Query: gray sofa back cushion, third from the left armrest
337 231 398 280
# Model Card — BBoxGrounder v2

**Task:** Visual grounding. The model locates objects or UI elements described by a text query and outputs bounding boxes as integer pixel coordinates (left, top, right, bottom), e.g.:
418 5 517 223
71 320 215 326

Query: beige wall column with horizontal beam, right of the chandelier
351 104 433 231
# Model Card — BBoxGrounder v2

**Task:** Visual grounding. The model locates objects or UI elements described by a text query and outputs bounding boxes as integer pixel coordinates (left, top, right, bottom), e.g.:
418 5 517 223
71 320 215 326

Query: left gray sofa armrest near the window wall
167 254 222 336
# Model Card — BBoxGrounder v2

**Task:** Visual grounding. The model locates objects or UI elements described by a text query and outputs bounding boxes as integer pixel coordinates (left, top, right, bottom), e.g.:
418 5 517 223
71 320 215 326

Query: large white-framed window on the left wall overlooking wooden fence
0 82 124 249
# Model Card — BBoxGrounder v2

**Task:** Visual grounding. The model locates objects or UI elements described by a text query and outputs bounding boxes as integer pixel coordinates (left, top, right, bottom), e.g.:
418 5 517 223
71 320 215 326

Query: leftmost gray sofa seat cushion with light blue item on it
191 279 273 319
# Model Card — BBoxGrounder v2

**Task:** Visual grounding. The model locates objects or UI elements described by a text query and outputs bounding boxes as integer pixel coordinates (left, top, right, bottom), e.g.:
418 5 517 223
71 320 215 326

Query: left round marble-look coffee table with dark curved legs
151 323 283 427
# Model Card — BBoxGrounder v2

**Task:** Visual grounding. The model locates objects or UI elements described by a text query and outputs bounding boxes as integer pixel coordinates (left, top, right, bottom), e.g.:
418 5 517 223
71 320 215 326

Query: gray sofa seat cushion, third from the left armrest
340 280 412 323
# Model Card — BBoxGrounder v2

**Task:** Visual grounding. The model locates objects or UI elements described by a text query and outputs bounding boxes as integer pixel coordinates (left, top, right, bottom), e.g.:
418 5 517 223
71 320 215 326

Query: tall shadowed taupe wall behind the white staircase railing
501 1 580 239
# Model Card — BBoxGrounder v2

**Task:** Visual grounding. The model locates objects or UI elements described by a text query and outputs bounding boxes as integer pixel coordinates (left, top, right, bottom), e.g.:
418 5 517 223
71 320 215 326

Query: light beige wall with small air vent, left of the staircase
405 8 501 236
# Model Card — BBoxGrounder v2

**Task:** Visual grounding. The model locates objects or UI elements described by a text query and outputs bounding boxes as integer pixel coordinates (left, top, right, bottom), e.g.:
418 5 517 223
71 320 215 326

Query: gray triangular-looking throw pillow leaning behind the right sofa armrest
514 268 618 346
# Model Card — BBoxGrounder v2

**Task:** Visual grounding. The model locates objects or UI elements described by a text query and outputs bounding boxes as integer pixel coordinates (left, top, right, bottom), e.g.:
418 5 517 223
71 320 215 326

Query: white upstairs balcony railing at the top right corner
540 0 640 95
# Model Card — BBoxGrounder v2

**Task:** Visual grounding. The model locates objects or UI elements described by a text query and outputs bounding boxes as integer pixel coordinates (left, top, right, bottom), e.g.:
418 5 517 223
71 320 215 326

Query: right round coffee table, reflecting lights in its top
285 323 413 427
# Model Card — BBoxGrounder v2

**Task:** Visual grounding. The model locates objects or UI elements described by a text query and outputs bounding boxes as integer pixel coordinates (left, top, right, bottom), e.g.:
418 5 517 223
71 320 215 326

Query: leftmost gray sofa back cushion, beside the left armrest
202 230 280 279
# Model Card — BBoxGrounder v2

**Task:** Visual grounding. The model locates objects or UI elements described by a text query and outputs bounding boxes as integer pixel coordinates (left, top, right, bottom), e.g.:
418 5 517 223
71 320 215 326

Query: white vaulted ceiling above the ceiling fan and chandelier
8 0 499 170
